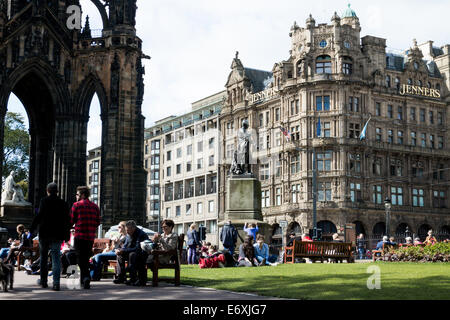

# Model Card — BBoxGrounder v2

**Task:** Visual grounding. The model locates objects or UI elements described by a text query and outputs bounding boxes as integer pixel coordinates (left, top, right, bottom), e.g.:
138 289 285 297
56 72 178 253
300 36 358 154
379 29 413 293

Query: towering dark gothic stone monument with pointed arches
0 0 147 227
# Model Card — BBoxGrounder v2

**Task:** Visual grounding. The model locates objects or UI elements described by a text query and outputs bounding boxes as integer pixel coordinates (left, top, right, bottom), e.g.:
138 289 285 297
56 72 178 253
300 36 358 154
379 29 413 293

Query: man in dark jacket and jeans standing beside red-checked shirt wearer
30 182 70 291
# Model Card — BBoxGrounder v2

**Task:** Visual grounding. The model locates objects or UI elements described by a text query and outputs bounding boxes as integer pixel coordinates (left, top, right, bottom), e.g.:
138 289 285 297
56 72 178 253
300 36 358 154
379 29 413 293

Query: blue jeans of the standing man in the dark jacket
39 239 62 285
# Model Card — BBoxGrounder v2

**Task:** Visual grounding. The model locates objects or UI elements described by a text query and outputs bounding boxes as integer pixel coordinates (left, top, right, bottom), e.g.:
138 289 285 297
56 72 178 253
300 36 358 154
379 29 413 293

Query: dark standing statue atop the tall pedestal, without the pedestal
230 120 252 175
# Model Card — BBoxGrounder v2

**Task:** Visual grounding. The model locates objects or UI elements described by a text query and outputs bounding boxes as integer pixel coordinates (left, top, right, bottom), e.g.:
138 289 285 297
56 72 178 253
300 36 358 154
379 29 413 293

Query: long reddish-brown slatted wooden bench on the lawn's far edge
284 240 354 263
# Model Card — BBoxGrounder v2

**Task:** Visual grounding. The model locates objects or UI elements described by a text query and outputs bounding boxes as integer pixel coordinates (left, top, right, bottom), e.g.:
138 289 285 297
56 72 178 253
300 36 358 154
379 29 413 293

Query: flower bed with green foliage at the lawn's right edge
381 242 450 262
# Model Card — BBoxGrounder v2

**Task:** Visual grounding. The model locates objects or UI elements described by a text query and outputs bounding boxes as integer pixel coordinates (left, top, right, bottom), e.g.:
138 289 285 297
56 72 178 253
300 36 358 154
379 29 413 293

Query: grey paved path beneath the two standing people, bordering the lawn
0 271 277 300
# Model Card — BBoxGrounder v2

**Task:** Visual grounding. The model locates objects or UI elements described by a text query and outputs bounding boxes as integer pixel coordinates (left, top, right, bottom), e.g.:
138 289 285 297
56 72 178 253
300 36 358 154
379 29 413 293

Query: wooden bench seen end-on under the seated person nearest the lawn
146 234 184 287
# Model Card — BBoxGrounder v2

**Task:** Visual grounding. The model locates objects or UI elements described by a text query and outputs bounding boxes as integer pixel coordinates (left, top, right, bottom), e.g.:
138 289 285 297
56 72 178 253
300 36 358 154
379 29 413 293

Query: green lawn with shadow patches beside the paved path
149 262 450 300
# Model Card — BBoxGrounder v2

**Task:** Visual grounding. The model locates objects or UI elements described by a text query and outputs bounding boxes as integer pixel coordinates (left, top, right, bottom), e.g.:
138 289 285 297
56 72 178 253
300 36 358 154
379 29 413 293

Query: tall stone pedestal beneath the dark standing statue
218 174 270 252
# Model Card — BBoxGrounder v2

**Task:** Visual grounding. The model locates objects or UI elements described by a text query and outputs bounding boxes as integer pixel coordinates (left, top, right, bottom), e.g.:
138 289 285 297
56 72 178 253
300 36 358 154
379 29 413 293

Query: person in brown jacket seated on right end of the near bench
146 219 178 269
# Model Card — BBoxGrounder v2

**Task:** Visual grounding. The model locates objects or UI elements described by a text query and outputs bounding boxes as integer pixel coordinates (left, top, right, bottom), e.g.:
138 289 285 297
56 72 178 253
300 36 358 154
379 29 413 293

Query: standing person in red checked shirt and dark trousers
70 186 100 289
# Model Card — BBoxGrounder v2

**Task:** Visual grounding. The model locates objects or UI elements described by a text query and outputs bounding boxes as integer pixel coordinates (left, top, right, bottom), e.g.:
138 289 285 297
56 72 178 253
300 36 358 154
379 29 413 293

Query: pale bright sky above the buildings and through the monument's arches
8 0 450 149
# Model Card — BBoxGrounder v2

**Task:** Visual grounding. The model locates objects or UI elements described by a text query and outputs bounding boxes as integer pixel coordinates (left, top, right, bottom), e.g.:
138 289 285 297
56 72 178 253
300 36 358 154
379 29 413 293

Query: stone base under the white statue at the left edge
0 205 34 238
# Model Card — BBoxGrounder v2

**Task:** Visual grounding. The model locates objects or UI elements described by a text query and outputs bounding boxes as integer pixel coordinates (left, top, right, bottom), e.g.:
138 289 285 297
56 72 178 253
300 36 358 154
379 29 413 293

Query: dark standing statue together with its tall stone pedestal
219 120 269 250
